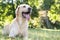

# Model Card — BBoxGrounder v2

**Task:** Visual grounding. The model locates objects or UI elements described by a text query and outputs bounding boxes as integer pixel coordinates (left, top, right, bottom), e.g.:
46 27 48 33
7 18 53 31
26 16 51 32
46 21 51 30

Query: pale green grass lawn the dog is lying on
0 29 60 40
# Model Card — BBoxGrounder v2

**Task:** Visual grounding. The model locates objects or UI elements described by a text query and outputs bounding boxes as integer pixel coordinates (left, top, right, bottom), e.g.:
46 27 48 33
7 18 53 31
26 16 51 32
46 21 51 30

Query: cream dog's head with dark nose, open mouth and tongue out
16 4 32 20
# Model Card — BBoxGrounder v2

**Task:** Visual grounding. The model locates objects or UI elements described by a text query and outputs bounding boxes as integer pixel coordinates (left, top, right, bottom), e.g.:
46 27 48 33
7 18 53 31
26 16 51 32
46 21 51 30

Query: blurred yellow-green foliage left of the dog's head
0 2 14 26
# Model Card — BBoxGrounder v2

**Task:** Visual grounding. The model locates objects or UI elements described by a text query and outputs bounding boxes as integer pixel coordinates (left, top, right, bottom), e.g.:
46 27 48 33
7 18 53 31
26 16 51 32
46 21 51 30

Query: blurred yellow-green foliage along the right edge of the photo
48 0 60 29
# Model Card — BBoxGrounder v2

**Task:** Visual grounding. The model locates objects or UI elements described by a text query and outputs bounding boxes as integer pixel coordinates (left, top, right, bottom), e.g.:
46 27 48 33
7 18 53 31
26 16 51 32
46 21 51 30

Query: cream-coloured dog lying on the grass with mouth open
2 4 32 40
